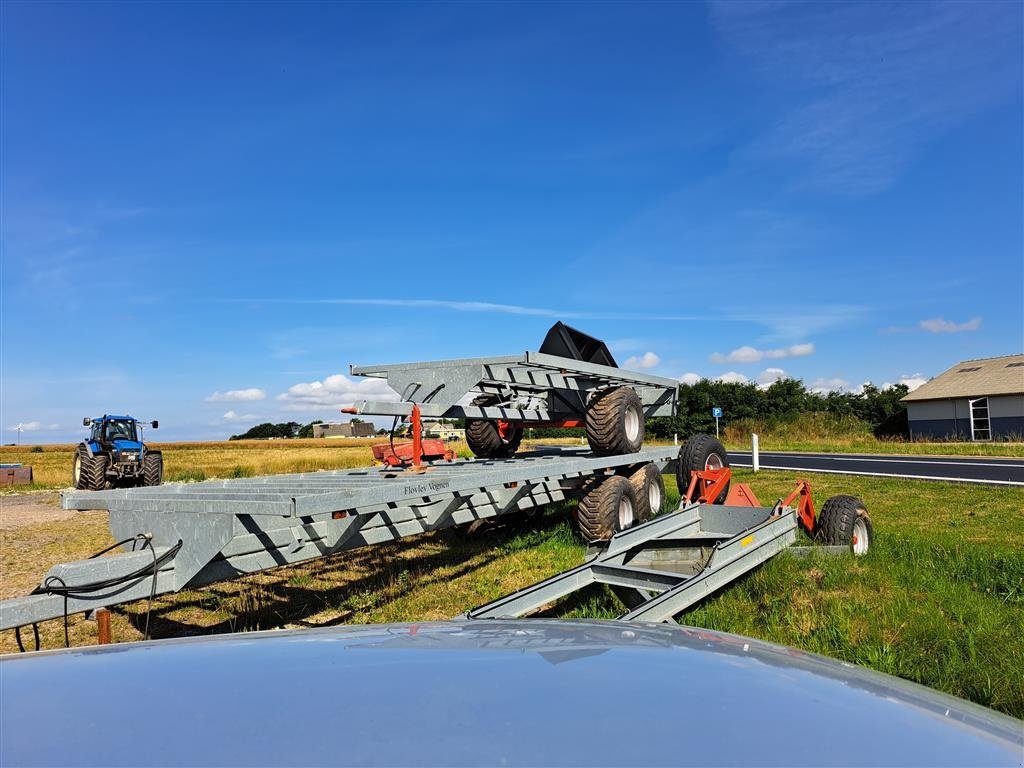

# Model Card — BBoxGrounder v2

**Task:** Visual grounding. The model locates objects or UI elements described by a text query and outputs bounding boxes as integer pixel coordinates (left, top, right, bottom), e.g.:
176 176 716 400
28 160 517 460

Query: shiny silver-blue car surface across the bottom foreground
0 620 1024 766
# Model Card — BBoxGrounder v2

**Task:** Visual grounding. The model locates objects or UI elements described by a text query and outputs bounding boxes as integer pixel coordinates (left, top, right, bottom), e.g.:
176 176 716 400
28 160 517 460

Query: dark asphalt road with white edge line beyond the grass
729 451 1024 485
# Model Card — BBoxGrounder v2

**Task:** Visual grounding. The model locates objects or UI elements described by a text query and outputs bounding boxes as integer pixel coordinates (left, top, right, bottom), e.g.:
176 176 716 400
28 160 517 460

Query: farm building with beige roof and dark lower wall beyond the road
903 354 1024 440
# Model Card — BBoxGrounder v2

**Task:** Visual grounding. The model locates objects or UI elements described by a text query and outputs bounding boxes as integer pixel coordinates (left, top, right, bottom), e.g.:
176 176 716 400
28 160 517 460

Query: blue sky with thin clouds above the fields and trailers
0 2 1024 442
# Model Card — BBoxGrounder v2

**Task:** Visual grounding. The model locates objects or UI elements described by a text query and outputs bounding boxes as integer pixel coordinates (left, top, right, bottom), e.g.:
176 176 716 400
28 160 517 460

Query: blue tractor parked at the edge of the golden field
72 415 164 490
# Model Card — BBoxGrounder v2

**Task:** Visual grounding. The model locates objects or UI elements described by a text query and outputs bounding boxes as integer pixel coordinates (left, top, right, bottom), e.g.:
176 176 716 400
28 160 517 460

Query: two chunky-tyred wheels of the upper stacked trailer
466 387 644 459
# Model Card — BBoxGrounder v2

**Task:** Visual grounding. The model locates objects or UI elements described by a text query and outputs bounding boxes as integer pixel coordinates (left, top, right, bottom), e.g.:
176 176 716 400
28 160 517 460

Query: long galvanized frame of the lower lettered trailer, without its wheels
0 445 678 630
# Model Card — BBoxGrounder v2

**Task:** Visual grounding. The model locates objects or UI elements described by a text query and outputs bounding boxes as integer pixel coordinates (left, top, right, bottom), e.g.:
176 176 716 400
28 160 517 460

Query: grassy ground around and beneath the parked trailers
0 460 1024 717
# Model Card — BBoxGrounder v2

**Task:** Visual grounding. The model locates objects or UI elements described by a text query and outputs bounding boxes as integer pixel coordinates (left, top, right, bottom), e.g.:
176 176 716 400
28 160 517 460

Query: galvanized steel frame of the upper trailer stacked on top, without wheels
346 352 679 423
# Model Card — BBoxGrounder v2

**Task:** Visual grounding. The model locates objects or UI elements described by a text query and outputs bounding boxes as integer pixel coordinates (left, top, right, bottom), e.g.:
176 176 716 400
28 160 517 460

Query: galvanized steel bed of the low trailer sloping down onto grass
466 504 798 622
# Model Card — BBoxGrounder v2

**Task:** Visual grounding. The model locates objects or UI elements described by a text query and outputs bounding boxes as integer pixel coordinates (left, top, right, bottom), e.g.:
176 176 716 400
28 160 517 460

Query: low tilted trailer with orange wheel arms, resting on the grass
465 469 873 622
